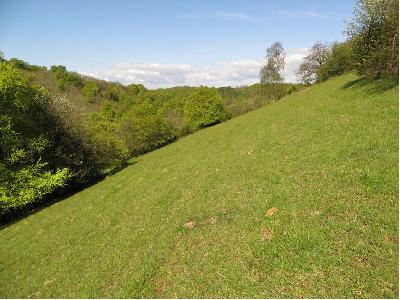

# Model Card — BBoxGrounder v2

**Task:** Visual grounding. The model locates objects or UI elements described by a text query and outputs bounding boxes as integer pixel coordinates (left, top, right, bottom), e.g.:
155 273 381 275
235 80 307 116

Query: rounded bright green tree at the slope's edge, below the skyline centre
184 87 226 130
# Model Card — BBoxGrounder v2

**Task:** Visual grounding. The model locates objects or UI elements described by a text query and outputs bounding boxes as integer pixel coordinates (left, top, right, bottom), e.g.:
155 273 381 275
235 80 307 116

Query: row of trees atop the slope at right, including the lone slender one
260 0 399 87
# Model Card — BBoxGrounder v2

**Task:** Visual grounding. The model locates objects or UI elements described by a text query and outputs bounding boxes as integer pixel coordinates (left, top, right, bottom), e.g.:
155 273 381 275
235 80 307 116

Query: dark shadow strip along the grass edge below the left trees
0 158 138 230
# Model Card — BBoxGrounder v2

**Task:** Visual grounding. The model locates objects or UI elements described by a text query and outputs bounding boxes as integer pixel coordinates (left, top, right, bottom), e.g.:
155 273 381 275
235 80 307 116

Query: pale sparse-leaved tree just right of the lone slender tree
296 42 331 84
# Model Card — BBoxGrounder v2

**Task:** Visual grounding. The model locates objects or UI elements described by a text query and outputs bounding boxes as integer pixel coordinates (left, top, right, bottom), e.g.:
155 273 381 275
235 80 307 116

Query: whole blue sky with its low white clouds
0 0 355 88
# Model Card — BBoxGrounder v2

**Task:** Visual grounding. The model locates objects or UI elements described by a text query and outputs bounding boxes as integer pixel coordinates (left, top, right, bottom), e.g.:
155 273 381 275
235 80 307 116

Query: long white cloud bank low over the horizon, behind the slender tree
83 48 308 89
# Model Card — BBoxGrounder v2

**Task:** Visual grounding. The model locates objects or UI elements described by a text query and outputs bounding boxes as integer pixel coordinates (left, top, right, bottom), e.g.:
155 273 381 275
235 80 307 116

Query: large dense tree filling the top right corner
347 0 399 78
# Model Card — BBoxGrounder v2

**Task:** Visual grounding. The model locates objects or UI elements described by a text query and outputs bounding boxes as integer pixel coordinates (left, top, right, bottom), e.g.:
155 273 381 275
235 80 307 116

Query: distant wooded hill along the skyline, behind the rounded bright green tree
10 58 304 116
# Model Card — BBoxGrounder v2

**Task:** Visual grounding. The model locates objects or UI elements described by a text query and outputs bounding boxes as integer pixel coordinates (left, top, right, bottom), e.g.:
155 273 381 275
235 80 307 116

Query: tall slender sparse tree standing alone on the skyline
260 42 285 84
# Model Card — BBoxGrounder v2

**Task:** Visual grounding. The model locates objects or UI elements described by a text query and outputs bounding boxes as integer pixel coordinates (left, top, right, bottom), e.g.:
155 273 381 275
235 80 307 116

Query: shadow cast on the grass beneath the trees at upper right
342 78 399 94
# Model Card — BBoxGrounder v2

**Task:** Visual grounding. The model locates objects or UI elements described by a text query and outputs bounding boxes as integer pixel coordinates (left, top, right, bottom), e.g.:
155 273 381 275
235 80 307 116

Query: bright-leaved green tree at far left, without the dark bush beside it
0 63 70 215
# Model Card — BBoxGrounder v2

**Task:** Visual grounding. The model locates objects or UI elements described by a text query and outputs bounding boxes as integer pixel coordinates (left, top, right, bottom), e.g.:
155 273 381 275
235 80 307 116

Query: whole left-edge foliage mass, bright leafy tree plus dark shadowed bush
0 62 111 214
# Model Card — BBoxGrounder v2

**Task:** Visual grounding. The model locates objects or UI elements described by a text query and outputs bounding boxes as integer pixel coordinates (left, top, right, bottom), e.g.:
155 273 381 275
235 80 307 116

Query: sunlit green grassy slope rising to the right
0 75 398 297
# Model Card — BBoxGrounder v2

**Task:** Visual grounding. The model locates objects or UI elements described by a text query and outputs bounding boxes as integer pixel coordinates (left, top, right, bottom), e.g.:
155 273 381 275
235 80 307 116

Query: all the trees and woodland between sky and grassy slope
0 0 398 215
